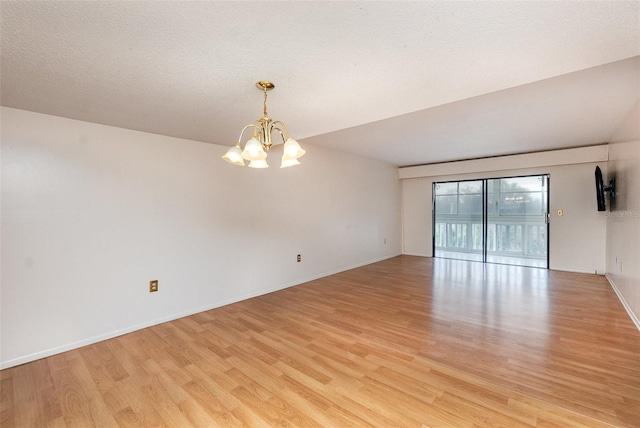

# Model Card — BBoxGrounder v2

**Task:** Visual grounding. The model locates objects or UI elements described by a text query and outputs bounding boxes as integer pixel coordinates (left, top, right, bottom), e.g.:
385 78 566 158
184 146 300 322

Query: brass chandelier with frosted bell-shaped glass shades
222 80 305 168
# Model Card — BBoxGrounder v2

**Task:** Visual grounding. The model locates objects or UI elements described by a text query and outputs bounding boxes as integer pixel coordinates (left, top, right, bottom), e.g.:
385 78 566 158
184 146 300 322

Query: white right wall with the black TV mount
607 102 640 329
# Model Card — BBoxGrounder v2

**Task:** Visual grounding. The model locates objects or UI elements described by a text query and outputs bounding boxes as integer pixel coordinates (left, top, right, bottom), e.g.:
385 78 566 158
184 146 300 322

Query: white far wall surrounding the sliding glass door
401 146 607 274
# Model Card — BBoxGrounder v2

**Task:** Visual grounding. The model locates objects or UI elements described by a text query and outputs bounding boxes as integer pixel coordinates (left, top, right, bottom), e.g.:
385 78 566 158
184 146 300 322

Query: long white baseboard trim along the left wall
0 253 401 370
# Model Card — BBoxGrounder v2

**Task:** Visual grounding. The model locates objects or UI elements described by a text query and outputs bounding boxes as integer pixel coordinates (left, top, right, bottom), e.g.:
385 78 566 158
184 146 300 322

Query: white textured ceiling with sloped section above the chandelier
0 1 640 166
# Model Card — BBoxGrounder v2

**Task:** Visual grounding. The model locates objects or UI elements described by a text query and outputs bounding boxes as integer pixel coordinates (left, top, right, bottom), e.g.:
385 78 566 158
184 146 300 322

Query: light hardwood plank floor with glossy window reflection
0 256 640 428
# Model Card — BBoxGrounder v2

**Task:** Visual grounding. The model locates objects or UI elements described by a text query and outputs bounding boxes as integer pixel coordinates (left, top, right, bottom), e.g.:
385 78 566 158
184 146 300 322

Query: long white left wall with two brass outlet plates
0 108 401 367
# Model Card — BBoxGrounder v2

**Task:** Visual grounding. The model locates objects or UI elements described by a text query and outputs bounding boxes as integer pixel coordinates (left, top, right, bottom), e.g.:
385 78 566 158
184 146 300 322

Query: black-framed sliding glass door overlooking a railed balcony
433 175 549 268
